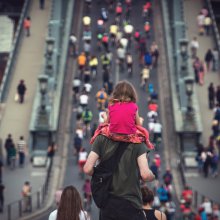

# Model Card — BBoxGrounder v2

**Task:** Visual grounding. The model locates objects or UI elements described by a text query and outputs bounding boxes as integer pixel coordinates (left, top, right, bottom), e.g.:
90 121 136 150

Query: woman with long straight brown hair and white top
48 186 90 220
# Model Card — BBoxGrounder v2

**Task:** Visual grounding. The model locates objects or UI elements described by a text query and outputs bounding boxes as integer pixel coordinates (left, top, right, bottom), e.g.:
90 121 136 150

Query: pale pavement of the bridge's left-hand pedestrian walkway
0 0 51 220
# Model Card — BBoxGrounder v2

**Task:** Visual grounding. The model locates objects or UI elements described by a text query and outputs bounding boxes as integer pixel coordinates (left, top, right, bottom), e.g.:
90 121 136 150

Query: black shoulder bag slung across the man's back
91 142 129 208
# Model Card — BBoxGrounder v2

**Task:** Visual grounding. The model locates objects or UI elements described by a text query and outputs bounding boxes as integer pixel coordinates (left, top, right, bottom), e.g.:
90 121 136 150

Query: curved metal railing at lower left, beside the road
6 158 52 220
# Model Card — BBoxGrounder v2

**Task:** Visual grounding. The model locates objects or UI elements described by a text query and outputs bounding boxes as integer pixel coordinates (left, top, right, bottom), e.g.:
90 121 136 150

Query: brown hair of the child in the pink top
110 80 137 103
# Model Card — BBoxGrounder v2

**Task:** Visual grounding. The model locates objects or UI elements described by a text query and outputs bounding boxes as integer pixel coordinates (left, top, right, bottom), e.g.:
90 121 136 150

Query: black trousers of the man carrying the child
99 197 146 220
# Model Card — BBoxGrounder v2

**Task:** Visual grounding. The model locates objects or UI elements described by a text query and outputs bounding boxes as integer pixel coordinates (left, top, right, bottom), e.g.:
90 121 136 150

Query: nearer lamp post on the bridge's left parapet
37 74 48 128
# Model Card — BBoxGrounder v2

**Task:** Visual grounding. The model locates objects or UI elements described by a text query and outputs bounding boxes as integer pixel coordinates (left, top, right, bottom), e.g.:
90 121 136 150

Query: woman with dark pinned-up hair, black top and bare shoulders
141 186 167 220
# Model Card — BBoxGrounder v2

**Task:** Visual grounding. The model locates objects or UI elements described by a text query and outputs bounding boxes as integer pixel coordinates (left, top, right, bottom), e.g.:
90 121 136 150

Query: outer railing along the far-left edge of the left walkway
0 0 31 102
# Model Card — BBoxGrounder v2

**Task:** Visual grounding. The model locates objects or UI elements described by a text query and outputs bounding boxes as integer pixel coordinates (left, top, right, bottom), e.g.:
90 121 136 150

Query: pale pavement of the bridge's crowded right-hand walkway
184 0 220 204
